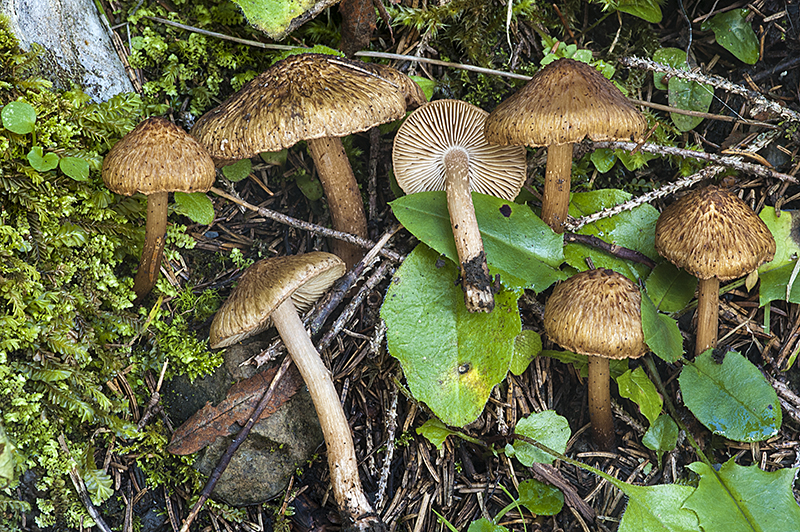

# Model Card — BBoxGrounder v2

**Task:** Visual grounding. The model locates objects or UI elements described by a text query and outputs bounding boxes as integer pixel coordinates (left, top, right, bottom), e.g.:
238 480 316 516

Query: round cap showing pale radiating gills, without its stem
392 100 526 200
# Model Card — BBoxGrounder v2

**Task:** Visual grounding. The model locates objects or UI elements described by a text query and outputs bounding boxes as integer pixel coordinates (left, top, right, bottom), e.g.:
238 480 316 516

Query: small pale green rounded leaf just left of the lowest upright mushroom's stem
513 410 570 467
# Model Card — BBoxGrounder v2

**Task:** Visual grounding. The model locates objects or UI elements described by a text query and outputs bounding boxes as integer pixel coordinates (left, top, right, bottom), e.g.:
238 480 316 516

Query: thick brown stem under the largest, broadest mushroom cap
308 137 368 270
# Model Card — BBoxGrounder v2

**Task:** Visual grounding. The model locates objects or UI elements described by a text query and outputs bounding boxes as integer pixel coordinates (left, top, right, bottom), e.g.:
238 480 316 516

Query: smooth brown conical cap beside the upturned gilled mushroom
486 59 647 147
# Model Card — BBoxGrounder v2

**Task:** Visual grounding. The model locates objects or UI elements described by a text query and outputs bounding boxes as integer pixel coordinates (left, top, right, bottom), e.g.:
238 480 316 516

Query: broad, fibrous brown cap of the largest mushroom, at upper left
192 54 425 160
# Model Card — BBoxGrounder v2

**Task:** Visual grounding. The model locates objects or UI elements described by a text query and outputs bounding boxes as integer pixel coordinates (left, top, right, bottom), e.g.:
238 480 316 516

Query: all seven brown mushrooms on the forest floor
98 54 775 530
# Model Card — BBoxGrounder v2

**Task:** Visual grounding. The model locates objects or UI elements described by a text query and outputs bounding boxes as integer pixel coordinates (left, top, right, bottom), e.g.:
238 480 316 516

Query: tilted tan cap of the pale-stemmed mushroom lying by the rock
209 251 345 348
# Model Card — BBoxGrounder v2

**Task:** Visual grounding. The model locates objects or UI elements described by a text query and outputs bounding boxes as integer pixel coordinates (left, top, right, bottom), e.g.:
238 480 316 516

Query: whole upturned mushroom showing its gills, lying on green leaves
392 100 526 312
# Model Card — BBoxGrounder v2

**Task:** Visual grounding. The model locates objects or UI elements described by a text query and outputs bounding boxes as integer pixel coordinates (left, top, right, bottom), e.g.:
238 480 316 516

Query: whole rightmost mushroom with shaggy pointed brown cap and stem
655 186 775 355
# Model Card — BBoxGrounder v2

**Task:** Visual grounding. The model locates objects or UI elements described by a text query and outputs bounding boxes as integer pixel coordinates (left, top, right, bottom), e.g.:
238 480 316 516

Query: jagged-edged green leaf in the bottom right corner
683 458 800 532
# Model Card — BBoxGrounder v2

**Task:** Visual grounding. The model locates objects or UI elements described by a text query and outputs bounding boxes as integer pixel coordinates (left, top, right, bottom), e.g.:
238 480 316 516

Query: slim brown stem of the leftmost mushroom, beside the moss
133 192 169 301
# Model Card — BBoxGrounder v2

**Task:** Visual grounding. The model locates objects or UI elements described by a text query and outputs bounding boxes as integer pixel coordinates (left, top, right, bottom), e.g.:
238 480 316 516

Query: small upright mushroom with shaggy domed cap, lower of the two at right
544 268 648 449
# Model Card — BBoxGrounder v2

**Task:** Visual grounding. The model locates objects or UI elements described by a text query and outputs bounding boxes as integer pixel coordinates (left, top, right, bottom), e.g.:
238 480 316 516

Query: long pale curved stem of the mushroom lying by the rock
271 298 385 531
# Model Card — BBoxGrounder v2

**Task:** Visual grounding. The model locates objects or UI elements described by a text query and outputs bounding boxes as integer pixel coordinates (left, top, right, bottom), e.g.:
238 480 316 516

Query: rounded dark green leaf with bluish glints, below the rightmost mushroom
678 349 782 442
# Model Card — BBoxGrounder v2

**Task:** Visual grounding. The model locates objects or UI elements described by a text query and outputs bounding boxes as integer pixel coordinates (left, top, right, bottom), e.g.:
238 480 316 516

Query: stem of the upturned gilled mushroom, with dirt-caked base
443 148 494 312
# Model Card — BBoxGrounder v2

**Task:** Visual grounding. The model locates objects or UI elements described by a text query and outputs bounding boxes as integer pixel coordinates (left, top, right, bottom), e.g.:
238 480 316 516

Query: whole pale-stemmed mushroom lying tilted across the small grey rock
209 251 385 530
